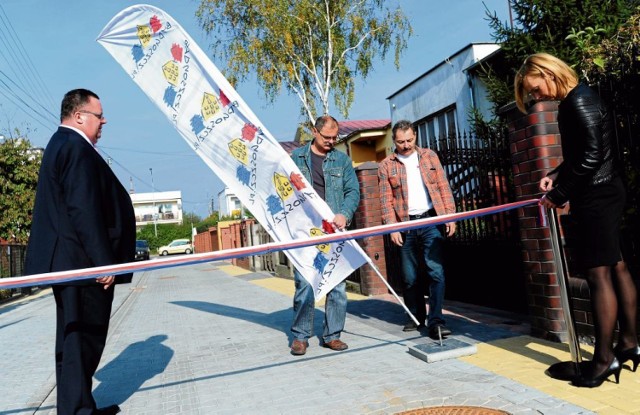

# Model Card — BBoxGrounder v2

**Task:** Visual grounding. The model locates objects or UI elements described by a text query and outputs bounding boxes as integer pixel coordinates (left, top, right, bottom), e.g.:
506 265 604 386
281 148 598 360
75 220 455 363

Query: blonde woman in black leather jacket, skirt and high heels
514 53 640 387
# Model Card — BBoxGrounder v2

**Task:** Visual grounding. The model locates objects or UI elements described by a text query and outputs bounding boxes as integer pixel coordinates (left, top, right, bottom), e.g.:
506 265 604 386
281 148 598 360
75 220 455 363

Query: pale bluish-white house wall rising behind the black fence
389 44 499 131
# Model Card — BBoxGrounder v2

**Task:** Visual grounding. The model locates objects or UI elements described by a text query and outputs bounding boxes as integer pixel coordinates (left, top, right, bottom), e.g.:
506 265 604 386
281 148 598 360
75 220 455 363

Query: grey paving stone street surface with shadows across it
0 263 592 415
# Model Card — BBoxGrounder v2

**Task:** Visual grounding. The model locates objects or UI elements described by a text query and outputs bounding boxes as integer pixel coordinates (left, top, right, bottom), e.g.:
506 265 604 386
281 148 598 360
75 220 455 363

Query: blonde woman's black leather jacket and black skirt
547 84 626 269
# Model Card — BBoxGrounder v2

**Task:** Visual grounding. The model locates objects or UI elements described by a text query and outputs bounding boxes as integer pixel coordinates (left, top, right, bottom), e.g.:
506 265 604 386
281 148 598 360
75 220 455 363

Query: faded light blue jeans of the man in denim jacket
291 269 347 343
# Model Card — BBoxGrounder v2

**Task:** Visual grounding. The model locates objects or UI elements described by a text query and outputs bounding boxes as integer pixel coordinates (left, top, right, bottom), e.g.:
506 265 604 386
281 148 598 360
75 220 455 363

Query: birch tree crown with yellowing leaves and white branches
196 0 412 121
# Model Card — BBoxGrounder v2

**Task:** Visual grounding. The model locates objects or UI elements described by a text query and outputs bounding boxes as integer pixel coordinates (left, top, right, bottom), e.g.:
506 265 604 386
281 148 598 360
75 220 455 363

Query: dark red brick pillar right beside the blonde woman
509 102 567 342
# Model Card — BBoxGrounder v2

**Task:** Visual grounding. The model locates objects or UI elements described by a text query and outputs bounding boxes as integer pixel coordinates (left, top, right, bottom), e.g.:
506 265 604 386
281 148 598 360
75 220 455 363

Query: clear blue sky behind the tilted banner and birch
0 0 509 217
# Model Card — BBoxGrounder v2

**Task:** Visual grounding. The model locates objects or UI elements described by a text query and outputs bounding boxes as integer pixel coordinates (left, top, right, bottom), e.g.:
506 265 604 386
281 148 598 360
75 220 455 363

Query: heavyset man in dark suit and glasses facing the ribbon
25 89 136 415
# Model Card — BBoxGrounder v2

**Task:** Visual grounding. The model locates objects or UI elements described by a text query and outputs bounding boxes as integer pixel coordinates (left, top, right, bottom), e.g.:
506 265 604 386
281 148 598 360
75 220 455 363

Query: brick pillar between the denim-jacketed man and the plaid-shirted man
354 162 389 295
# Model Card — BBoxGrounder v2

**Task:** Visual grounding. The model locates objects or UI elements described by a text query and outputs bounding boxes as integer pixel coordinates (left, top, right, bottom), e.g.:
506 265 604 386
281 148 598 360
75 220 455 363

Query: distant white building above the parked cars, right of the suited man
131 190 182 227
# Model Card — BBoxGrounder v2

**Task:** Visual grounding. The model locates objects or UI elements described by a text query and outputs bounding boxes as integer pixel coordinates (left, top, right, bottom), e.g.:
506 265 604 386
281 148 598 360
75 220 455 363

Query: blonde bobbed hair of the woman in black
513 53 578 113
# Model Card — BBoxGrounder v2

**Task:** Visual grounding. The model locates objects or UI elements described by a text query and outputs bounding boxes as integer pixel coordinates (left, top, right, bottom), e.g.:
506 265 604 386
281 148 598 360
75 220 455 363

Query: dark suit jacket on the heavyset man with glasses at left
25 127 136 285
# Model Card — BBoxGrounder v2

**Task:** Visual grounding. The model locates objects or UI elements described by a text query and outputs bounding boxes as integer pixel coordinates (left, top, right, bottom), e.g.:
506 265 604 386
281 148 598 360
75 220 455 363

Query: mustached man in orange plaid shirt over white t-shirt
378 120 456 339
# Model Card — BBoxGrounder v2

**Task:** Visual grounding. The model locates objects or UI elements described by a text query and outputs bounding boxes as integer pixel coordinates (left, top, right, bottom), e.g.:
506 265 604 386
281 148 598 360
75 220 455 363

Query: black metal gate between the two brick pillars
385 132 527 312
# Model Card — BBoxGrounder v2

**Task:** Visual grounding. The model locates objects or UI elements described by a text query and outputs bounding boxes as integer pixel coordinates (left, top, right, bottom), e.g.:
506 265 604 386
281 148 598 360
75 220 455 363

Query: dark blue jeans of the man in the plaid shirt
400 226 444 327
